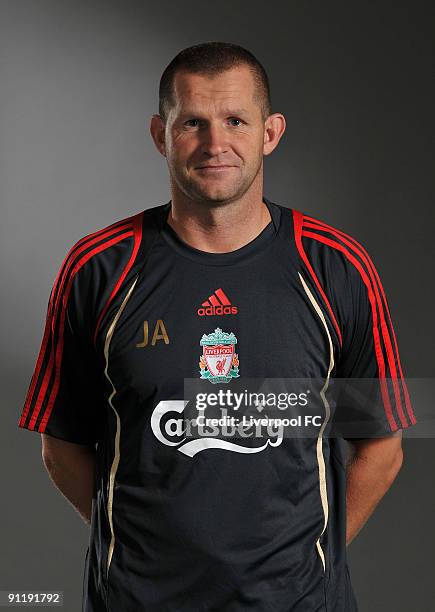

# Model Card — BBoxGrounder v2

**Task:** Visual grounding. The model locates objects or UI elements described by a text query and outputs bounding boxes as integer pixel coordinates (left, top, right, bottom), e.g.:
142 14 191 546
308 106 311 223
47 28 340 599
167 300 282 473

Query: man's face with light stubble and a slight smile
165 66 265 204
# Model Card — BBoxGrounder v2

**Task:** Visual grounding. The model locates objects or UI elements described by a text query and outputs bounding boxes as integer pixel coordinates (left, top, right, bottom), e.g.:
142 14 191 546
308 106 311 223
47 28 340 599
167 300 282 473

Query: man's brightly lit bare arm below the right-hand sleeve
346 430 403 545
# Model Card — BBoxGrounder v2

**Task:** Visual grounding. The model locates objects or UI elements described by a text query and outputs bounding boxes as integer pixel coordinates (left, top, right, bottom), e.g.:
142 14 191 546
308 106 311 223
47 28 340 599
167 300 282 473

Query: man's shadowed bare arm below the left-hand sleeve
41 434 95 524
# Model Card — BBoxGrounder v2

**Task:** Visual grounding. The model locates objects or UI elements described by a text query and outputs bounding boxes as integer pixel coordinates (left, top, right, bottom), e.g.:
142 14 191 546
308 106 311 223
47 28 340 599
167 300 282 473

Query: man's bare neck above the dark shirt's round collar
167 197 271 253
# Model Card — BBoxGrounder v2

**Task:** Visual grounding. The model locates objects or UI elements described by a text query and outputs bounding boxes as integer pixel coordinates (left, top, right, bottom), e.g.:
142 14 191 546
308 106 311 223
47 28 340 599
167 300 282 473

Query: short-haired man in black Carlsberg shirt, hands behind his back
19 43 415 612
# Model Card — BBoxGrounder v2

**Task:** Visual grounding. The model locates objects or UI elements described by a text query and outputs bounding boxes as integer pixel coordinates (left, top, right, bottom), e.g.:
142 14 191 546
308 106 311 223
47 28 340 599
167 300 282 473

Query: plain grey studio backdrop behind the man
0 0 435 612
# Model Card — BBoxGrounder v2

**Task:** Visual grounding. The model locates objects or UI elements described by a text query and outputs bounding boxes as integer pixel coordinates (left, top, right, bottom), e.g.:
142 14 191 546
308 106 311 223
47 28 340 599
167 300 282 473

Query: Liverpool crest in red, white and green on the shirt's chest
199 327 239 383
